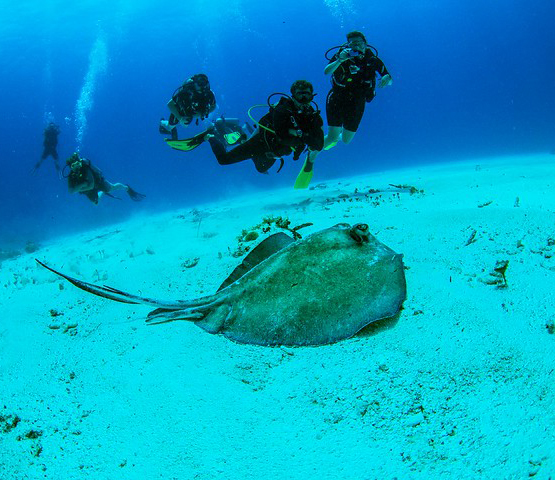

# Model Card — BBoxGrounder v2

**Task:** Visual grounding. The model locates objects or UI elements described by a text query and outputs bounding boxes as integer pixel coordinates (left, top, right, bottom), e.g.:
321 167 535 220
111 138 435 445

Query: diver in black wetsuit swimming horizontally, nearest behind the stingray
207 80 324 173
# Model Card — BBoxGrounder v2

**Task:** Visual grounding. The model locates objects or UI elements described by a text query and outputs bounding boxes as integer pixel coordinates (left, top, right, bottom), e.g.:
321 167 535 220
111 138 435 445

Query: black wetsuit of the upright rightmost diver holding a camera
326 48 389 132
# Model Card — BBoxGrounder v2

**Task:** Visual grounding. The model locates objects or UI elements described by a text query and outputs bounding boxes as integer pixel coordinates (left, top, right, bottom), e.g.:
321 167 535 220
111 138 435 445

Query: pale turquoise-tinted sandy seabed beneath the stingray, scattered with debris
0 156 555 479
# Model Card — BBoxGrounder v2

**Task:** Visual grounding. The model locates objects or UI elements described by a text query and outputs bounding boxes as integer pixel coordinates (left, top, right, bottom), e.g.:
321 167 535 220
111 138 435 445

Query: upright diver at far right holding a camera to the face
300 30 392 188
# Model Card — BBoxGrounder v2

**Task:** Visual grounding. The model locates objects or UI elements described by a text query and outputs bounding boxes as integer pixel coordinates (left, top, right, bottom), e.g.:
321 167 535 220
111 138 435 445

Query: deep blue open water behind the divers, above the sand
0 0 555 248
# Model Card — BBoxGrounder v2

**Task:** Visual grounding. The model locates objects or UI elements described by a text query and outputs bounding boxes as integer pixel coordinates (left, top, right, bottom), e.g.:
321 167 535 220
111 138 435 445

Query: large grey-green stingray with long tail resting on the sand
37 223 406 345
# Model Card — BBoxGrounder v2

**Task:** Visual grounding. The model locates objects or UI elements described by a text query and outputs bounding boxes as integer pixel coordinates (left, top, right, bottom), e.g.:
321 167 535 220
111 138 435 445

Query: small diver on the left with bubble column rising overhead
64 152 145 205
